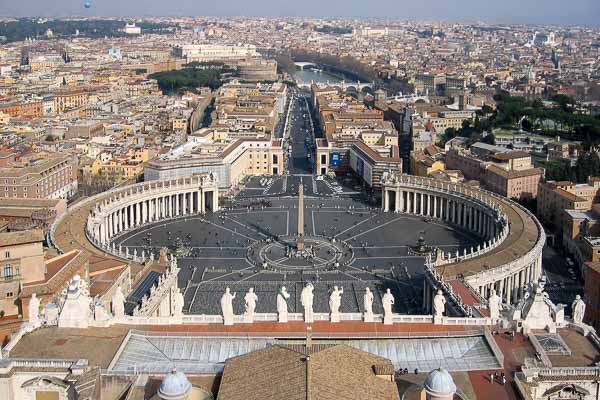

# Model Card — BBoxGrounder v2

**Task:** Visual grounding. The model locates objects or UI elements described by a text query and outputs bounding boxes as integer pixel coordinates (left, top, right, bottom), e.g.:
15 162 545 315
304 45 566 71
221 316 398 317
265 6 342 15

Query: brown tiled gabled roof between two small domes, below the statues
219 345 399 400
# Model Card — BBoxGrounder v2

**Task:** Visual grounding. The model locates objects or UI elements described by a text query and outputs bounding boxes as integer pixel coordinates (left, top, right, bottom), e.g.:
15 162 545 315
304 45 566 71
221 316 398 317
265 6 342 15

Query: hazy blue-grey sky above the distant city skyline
0 0 600 26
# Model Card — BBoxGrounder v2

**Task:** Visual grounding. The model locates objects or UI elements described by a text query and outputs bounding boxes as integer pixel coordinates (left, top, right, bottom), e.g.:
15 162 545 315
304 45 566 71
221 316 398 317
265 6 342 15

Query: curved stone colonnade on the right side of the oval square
382 174 546 311
